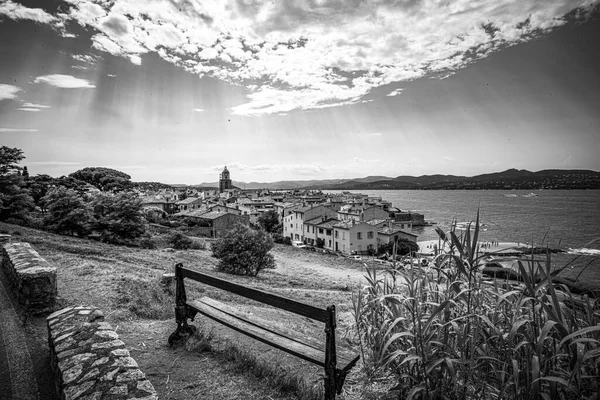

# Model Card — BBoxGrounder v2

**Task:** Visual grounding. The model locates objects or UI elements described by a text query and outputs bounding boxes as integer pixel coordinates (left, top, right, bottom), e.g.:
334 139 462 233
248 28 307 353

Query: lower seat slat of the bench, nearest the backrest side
187 300 325 367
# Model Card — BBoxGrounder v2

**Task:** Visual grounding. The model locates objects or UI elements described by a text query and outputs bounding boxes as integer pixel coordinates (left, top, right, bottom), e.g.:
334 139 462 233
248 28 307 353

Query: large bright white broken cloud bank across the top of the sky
0 0 600 115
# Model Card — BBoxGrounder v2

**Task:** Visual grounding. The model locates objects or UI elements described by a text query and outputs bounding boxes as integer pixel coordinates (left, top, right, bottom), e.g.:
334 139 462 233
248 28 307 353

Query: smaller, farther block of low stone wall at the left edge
1 243 57 312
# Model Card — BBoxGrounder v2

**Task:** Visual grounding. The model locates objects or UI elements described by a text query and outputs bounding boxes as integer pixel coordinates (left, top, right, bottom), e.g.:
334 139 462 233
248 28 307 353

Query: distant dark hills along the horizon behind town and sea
176 169 600 190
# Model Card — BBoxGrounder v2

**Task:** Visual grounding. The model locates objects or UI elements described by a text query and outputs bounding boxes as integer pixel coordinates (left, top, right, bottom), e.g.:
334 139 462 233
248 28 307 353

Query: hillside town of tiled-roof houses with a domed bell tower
138 167 425 255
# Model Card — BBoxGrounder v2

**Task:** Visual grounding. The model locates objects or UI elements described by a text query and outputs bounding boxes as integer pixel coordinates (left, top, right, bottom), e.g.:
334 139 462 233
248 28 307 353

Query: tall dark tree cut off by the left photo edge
0 146 34 221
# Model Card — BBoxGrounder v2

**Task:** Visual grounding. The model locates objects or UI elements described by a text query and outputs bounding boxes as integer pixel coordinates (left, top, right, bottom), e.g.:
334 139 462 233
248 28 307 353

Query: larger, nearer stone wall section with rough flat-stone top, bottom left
47 306 158 400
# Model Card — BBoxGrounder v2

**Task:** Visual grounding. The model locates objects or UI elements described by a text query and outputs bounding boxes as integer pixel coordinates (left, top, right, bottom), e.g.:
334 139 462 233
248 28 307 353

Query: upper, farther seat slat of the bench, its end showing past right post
197 296 358 369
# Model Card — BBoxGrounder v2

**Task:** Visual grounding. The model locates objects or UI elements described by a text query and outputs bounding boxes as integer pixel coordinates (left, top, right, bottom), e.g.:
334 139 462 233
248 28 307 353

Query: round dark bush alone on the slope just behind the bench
212 224 275 276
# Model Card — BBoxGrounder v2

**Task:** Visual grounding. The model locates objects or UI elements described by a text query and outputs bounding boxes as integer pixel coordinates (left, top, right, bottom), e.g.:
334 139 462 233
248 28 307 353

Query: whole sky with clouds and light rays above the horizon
0 0 600 184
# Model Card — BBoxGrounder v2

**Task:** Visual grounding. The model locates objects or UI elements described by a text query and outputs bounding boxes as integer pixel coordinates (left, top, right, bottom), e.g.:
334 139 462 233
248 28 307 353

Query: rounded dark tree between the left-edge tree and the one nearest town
42 187 94 236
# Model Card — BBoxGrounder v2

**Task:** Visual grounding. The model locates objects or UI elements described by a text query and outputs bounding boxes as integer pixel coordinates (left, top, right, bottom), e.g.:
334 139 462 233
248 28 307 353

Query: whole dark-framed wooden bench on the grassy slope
169 264 360 400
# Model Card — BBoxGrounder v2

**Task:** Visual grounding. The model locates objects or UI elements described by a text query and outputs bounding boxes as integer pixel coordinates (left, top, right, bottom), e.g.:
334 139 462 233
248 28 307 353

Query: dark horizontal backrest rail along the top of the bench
175 264 330 323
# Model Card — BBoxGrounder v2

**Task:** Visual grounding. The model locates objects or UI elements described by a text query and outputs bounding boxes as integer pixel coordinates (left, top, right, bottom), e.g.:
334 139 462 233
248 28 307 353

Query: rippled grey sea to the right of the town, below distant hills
326 190 600 253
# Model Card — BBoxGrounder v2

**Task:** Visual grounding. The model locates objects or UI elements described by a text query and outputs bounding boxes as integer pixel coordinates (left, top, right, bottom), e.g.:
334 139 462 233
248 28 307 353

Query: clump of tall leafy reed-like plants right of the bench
353 213 600 400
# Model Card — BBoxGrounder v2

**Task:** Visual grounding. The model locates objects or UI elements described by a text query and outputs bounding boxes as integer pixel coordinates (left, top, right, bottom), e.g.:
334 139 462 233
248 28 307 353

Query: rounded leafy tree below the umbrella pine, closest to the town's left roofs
92 192 146 244
